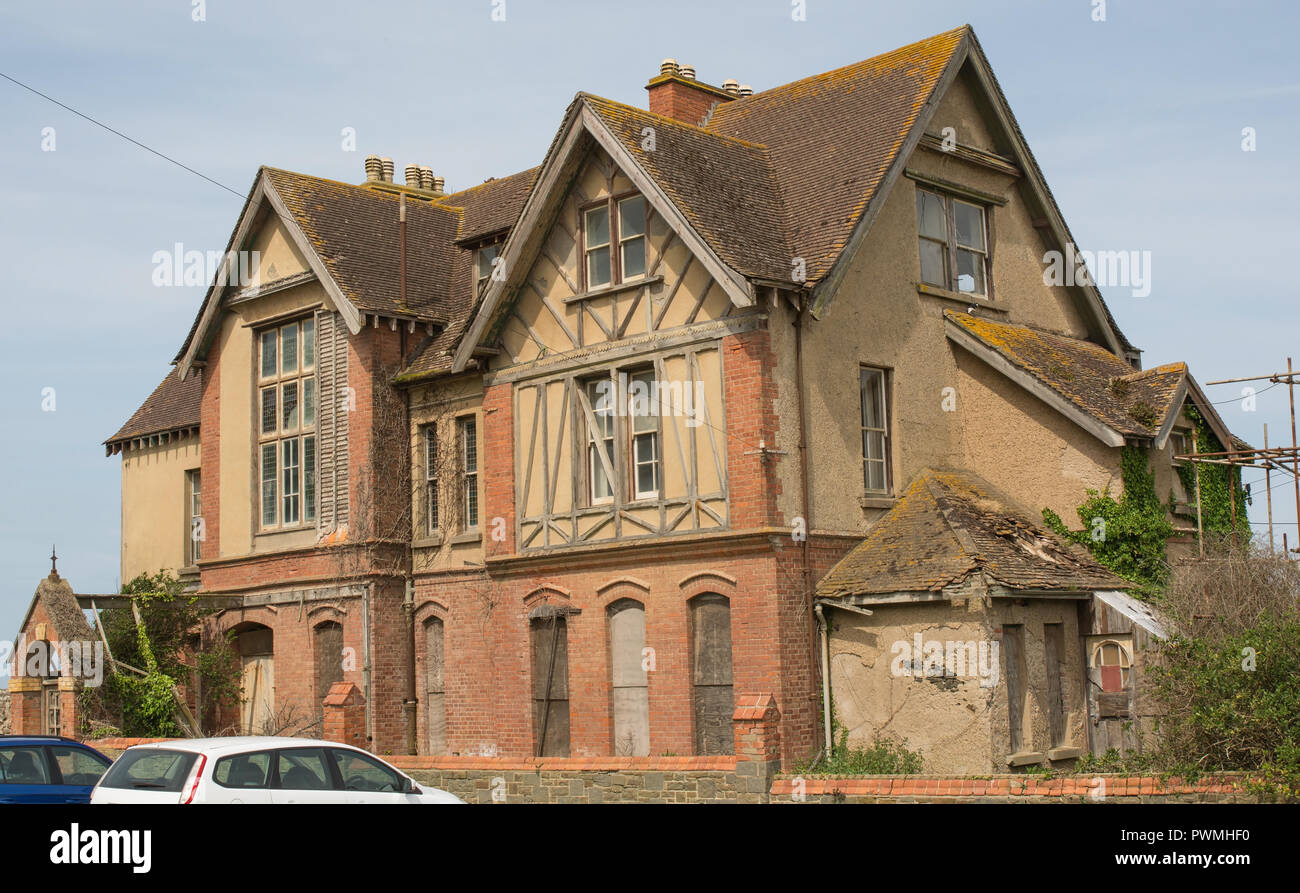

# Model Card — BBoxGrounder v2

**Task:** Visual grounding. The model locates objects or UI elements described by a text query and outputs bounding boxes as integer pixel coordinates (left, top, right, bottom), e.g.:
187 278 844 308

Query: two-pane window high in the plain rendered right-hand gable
917 190 988 295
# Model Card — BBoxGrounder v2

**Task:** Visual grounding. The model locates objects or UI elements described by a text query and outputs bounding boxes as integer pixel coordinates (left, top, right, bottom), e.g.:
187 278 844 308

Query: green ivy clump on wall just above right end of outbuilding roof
1043 446 1174 598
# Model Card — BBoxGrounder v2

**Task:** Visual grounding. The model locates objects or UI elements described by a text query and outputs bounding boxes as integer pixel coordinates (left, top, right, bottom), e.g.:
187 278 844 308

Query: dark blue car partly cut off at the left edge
0 734 113 803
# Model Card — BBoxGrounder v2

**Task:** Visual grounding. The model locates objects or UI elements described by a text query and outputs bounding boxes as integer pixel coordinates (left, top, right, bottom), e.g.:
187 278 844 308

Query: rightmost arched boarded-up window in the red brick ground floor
690 593 736 757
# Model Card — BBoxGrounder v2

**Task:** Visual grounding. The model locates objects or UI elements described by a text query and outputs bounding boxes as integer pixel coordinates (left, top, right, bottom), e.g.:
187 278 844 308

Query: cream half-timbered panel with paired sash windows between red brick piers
515 341 728 550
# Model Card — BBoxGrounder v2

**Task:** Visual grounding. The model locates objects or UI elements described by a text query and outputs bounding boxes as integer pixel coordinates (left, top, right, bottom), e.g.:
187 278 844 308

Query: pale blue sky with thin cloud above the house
0 0 1300 637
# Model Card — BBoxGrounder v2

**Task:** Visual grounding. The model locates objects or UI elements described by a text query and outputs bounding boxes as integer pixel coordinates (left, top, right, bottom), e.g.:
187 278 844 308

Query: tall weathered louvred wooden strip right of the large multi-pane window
316 311 348 533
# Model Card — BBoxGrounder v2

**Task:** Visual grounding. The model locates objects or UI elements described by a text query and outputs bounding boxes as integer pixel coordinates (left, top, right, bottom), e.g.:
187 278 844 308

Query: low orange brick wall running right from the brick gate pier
770 773 1260 803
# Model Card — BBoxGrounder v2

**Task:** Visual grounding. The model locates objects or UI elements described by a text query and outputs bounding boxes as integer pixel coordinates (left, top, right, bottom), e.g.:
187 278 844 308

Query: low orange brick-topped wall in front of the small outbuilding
771 772 1251 799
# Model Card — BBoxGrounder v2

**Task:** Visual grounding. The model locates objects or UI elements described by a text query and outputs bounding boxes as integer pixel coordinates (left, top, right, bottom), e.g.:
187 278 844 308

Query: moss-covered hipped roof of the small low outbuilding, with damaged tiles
816 469 1128 602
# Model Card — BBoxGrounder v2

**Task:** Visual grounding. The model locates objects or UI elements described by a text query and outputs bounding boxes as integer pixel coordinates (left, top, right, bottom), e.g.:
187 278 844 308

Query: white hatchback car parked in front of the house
90 737 464 803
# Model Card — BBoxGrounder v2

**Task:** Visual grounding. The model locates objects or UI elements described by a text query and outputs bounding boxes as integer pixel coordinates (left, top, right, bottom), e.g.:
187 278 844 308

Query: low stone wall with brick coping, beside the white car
385 757 771 803
